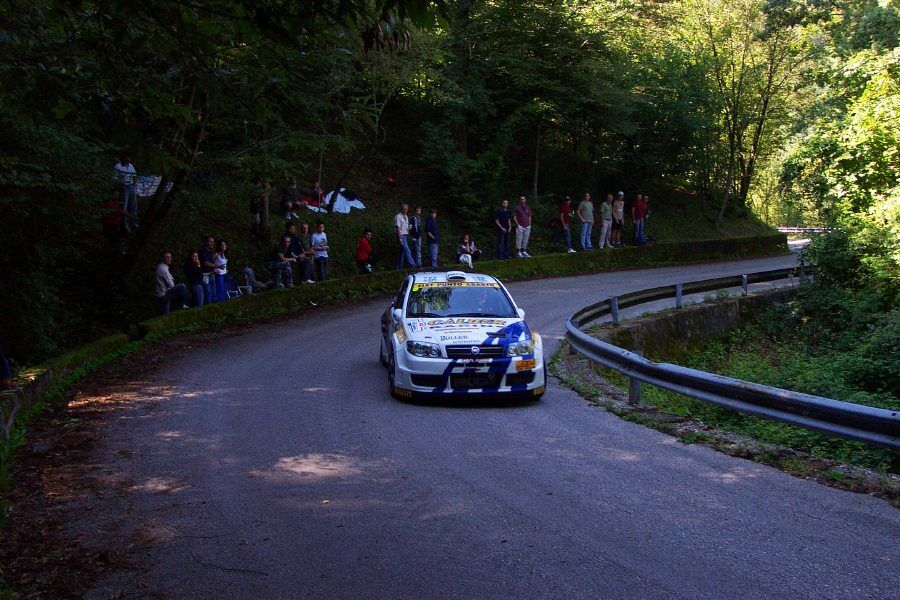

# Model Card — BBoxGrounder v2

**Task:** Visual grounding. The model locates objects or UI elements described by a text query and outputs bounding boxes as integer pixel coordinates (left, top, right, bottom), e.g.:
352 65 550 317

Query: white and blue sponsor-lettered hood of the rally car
405 317 531 344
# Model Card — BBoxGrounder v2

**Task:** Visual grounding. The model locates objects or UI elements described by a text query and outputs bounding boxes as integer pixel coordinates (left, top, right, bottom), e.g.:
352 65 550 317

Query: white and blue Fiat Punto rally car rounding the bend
379 271 546 398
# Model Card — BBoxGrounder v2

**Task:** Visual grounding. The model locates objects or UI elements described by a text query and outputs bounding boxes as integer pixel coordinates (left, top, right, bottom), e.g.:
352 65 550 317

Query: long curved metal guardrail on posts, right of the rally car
566 269 900 450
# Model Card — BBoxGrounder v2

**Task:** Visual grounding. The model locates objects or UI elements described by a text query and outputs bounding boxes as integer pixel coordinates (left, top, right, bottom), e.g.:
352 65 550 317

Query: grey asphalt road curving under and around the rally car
82 257 900 598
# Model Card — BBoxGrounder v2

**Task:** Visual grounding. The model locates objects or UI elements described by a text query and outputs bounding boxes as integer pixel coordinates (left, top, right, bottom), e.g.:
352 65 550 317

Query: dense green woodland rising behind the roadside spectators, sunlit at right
0 0 900 364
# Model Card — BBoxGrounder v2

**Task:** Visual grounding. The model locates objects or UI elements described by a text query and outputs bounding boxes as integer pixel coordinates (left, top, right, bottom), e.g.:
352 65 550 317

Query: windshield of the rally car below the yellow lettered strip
406 281 518 318
